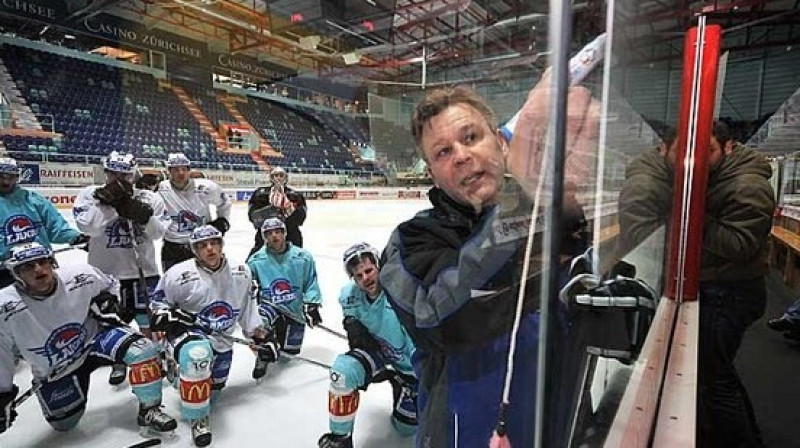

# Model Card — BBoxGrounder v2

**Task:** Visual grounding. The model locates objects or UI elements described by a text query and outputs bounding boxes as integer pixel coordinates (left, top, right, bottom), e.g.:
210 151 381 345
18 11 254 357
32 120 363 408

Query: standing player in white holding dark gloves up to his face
72 151 170 385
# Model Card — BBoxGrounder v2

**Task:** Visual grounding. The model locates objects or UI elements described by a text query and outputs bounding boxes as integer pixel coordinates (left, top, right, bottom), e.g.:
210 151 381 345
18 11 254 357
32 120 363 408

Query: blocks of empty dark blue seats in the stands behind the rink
0 44 378 172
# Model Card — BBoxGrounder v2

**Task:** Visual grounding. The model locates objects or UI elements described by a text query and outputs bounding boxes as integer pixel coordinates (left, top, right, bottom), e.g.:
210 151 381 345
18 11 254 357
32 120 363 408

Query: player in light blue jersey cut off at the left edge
0 157 88 288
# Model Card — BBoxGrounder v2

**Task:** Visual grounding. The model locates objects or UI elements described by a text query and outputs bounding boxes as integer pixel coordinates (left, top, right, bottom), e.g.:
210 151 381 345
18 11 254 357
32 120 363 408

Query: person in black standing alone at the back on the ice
247 166 307 255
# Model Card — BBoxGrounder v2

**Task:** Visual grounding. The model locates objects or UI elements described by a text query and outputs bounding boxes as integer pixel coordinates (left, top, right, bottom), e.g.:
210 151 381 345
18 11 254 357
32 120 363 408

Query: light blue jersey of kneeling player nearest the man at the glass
339 281 415 375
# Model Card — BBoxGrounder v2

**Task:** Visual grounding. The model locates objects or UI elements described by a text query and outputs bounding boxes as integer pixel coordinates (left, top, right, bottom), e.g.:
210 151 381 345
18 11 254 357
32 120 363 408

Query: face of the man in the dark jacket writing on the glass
422 104 505 210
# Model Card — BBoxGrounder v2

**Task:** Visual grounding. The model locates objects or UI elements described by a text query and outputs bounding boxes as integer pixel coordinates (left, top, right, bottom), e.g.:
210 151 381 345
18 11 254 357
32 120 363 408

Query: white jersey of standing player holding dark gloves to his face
72 185 171 280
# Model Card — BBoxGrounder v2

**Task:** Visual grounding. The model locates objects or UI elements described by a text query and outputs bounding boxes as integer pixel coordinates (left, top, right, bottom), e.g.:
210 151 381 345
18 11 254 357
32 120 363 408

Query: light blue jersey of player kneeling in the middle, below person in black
247 243 322 320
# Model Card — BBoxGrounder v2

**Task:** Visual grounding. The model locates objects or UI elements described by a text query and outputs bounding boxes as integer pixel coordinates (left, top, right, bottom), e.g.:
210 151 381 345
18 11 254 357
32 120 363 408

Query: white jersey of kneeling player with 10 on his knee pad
150 258 261 352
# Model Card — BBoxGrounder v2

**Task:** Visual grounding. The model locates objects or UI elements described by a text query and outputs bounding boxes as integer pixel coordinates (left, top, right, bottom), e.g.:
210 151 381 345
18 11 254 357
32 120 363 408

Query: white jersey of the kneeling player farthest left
0 263 119 392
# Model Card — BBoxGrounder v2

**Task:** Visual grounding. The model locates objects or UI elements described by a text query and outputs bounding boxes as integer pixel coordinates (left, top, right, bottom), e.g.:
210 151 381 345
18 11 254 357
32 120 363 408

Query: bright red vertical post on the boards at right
666 25 722 301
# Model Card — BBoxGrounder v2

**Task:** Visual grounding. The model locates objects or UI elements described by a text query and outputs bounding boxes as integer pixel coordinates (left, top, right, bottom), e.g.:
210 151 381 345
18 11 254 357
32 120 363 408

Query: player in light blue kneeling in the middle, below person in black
247 218 322 379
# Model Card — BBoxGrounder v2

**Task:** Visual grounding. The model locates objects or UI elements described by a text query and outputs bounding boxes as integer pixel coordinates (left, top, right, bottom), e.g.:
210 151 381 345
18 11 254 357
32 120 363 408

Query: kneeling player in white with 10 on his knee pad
150 225 280 446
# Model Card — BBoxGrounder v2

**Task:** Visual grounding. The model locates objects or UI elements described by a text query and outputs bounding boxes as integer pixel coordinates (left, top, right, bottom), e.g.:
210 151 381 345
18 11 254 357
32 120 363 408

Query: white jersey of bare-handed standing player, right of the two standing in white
158 179 232 244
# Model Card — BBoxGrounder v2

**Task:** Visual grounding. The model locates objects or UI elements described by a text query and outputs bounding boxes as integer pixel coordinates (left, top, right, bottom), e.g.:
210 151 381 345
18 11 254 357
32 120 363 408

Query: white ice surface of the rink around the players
0 200 428 448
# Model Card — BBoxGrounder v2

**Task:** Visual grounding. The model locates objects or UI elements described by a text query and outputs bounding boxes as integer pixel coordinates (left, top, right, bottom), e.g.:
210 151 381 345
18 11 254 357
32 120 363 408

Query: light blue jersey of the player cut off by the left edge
0 186 80 260
